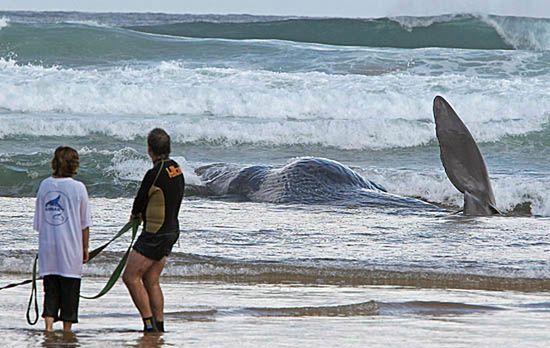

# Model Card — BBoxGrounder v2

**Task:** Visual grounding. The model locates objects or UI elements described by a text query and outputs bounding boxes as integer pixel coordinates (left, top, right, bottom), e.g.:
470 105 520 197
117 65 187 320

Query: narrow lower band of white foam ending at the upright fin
0 116 442 149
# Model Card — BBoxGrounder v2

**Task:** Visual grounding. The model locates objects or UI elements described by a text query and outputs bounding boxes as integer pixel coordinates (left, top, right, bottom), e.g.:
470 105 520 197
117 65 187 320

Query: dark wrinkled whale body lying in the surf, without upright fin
196 157 437 209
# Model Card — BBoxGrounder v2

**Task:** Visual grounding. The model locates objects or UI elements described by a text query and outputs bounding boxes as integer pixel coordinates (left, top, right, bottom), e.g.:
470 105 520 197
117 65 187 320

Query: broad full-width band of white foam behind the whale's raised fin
0 59 550 149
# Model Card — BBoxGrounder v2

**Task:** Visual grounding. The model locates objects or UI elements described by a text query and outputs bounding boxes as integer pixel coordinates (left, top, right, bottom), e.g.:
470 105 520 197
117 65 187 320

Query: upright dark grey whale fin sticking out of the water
433 96 499 215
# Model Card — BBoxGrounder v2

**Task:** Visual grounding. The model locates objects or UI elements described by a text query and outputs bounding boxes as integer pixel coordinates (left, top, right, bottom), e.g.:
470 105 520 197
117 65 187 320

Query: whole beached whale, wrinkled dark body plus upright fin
190 96 497 215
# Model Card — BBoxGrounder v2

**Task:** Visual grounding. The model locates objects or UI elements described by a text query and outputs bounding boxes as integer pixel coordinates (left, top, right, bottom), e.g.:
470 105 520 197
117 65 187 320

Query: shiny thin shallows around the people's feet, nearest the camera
0 277 550 347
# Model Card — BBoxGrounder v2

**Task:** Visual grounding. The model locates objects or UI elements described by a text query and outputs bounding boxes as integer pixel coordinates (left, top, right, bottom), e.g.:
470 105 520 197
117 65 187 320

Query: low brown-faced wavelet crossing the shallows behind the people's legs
0 251 550 292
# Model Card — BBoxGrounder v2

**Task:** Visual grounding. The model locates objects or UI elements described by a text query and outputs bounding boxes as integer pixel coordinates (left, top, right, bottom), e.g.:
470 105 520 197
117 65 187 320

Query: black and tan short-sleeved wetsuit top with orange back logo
132 159 185 234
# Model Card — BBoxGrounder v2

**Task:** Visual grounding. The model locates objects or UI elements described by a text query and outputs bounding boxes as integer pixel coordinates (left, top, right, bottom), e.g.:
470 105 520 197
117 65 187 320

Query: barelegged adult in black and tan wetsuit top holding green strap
122 128 185 332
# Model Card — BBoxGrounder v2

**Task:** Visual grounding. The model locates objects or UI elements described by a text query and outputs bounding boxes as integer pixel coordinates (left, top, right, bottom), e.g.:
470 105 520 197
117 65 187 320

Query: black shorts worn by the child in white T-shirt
42 275 80 323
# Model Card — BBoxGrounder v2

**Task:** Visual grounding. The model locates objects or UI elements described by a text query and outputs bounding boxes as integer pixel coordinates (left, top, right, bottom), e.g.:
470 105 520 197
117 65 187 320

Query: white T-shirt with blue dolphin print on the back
34 177 91 278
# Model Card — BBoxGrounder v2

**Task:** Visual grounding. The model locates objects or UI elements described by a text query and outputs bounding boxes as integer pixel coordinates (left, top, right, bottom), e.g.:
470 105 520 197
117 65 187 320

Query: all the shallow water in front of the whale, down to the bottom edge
0 198 550 347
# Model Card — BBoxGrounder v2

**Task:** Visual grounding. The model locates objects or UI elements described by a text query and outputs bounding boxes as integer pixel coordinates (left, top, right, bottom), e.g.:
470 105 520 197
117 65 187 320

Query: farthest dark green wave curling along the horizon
0 12 550 50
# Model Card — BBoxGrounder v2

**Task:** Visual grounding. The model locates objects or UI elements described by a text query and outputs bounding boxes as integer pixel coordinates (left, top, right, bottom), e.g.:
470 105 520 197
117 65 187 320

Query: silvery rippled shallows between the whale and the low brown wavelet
0 198 550 282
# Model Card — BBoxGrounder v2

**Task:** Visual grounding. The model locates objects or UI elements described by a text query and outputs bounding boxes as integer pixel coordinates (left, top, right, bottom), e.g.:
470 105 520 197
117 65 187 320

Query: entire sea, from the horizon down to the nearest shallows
0 12 550 347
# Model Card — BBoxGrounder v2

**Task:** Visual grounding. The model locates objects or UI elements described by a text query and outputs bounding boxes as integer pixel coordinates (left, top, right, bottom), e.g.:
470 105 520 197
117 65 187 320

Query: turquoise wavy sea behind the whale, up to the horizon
0 12 550 216
